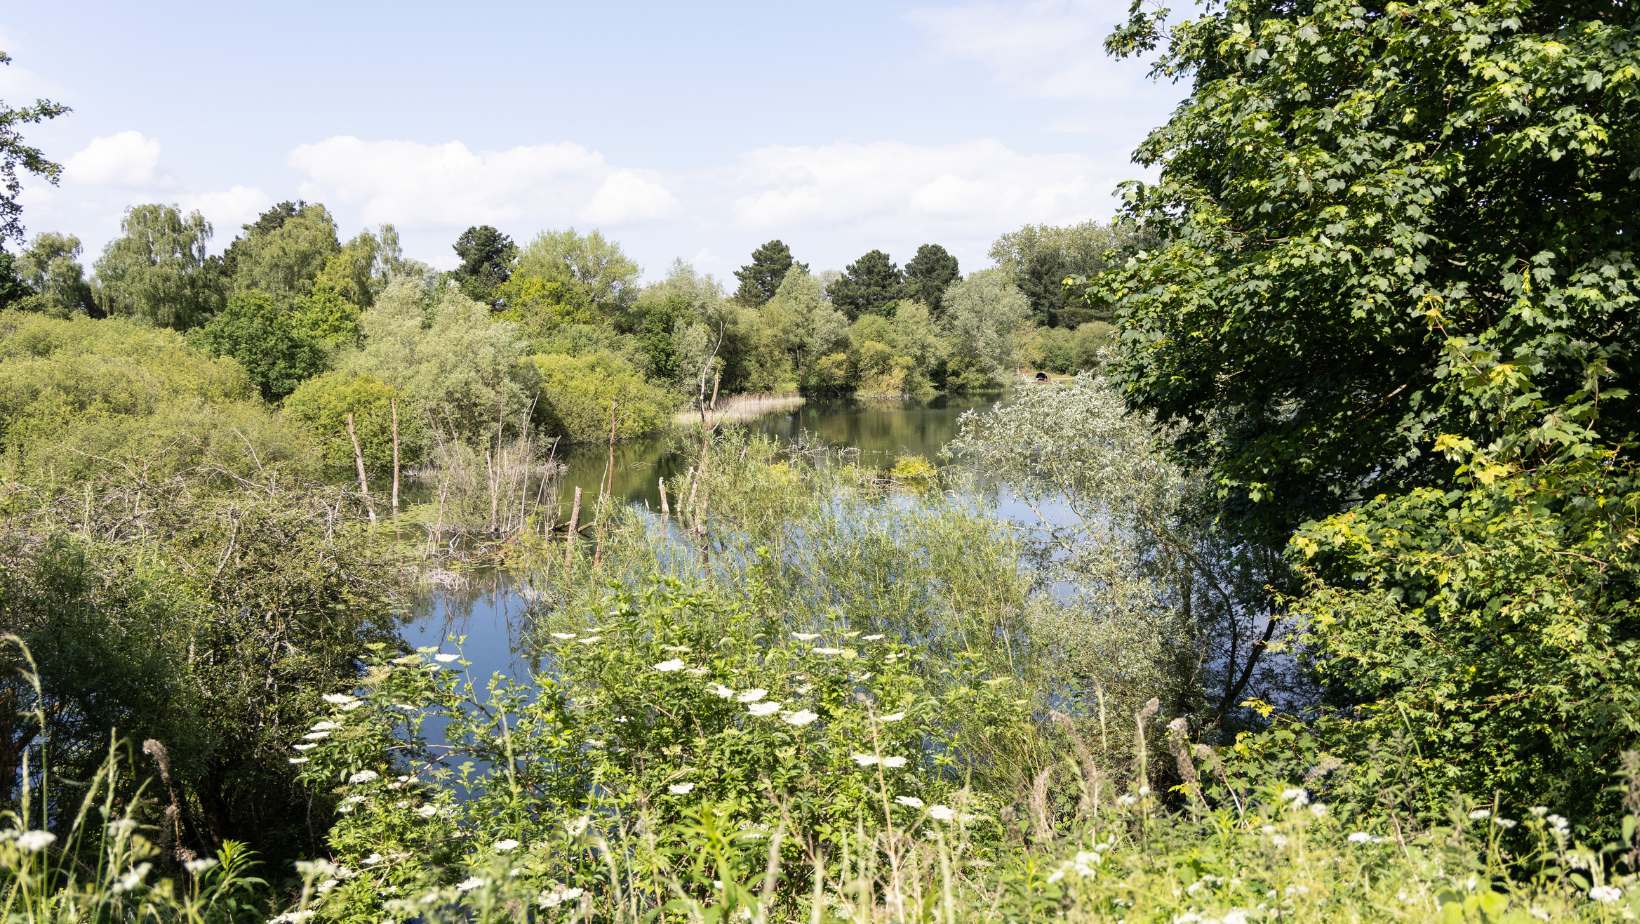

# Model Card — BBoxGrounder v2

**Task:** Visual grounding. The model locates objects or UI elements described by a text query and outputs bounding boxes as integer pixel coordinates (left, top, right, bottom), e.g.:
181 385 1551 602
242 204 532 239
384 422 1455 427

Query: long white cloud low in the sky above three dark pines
733 140 1125 235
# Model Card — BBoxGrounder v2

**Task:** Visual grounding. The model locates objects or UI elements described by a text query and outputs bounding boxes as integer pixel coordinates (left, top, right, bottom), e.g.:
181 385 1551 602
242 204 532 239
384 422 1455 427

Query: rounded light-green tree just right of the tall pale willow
225 202 339 299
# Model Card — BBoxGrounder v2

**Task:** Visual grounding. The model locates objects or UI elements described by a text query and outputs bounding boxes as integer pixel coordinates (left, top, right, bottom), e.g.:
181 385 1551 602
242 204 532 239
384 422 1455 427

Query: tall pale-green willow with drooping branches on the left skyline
95 205 223 330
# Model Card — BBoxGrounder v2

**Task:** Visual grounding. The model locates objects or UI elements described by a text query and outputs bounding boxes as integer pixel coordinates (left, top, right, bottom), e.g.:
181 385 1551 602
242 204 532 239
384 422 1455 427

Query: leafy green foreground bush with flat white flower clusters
292 579 1032 921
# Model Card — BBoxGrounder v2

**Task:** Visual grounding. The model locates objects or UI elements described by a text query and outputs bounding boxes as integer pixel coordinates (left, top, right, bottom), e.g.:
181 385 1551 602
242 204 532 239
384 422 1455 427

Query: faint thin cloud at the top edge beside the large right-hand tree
909 0 1145 100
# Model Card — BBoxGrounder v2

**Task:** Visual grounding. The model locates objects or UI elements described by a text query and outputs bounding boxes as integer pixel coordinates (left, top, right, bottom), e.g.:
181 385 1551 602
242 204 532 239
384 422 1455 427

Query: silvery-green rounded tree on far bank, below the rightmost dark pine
941 269 1030 391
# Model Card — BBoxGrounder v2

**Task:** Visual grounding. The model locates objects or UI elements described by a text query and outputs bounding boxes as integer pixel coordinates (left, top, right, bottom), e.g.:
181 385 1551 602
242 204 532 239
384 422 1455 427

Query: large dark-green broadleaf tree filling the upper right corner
1092 0 1640 542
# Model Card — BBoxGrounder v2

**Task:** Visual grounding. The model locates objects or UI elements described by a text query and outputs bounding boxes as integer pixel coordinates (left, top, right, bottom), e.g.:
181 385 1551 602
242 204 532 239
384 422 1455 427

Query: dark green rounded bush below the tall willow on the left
195 290 326 400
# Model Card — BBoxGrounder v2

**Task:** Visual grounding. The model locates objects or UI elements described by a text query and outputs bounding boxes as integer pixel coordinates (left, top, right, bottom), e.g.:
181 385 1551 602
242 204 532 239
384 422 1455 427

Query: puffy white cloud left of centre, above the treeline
289 136 677 228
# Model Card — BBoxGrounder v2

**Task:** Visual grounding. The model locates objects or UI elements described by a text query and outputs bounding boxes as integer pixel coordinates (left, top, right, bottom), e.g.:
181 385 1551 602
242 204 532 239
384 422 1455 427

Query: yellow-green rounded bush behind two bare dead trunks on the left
284 373 428 479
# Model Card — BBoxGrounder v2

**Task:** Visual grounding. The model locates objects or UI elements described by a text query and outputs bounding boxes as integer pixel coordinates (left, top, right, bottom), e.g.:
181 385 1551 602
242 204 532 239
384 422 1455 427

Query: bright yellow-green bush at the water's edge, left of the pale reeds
530 353 677 443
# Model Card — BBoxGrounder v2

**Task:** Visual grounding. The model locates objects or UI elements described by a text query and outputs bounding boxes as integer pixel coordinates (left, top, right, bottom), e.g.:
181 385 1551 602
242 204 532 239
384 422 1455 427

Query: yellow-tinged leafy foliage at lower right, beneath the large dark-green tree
1294 437 1640 834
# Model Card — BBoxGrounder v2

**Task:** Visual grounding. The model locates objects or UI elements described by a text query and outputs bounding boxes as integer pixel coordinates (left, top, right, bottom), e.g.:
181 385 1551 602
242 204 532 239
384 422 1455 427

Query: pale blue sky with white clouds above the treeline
0 0 1182 282
